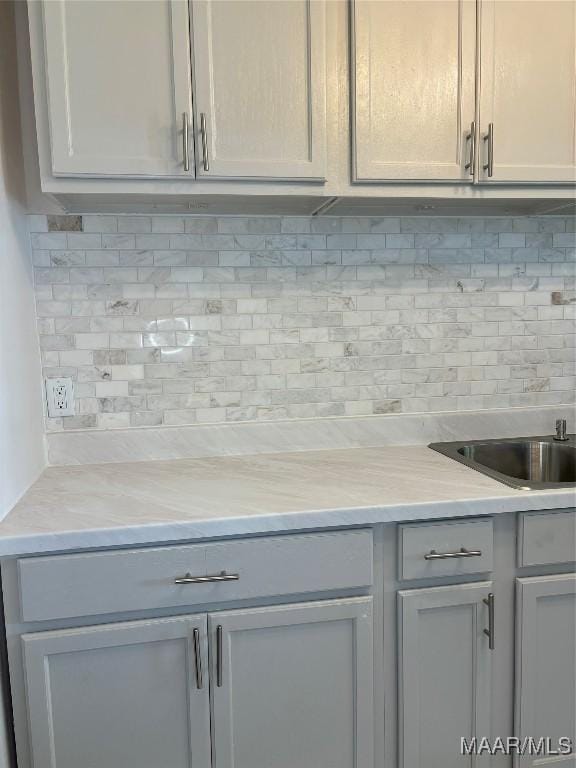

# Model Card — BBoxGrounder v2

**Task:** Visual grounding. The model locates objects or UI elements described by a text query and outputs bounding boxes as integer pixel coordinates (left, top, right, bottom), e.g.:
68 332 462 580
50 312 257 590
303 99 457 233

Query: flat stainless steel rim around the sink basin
428 433 576 491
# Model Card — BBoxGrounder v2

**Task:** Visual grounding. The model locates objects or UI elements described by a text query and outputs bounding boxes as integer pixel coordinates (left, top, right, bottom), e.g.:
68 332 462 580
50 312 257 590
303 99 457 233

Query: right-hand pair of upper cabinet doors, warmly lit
351 0 576 184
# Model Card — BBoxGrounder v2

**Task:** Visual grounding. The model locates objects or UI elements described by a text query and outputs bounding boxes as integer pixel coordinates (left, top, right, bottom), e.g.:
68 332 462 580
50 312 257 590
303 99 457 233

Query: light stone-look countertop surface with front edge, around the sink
0 446 576 556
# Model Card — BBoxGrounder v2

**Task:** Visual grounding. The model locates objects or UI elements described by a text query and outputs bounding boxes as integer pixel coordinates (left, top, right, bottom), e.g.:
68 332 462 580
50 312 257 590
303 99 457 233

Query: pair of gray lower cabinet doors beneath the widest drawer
22 597 374 768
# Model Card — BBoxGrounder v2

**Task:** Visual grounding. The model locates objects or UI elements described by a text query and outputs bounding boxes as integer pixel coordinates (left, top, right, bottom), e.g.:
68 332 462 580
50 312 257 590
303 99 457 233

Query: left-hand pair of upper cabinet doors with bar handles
32 0 326 181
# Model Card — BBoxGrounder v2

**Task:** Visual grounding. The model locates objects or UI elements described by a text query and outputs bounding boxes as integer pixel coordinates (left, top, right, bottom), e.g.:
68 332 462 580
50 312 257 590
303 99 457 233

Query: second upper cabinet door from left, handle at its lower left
192 0 326 180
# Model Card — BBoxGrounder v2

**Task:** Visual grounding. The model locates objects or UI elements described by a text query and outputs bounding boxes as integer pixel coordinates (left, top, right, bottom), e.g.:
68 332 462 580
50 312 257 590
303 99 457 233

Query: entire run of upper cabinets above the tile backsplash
23 0 576 198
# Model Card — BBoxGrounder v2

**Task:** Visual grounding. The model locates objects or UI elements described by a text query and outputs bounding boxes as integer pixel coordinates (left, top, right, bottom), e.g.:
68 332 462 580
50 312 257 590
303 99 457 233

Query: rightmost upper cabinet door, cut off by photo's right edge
479 0 576 183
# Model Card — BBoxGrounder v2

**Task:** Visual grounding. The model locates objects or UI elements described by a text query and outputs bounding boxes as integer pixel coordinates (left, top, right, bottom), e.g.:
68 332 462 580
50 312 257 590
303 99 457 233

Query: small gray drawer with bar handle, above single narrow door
398 518 494 580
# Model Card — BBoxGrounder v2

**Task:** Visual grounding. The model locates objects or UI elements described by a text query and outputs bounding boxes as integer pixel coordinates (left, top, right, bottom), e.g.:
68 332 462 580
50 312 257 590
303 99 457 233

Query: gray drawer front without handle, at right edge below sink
518 509 576 568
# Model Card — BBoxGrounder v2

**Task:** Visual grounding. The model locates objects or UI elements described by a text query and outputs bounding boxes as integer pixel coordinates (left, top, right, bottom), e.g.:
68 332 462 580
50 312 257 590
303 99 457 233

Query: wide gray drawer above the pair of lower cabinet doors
18 530 373 621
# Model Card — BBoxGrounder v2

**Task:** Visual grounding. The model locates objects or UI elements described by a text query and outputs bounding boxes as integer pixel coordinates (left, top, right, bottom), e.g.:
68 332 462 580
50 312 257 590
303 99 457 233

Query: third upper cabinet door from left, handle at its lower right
351 0 476 181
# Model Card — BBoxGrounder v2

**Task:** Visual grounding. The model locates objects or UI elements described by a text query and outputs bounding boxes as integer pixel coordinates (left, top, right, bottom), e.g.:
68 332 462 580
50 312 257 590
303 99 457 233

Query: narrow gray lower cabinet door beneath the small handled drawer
398 582 492 768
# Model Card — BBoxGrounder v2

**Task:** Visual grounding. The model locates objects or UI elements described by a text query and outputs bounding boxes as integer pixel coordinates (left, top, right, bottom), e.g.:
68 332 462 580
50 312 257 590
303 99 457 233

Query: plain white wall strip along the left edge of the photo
0 2 45 517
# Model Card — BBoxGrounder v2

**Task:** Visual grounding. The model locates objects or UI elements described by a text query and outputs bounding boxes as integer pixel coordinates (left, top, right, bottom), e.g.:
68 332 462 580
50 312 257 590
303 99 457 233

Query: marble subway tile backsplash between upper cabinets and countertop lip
29 215 576 431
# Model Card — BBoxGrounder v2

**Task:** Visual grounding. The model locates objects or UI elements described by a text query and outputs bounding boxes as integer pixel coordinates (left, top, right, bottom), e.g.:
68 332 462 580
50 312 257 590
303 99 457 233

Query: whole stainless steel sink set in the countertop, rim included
429 435 576 490
